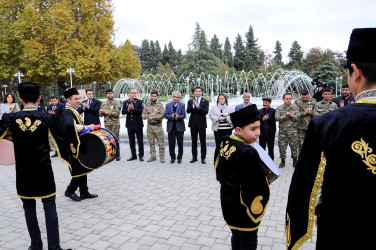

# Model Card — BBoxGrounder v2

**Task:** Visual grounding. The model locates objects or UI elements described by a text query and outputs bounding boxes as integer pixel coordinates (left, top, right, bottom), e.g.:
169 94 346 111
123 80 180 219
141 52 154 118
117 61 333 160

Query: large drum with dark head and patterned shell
78 128 119 169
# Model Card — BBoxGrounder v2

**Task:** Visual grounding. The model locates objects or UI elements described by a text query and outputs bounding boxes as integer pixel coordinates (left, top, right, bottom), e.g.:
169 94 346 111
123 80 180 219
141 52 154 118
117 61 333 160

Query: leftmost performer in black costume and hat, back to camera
0 83 69 250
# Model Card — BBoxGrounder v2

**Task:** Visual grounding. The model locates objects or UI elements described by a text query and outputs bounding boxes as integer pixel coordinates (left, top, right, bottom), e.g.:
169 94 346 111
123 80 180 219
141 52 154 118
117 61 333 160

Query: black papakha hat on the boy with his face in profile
230 104 260 128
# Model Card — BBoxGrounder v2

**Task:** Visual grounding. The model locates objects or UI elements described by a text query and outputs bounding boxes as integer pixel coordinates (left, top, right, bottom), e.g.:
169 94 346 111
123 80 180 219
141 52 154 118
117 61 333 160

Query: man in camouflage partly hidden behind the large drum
99 89 121 161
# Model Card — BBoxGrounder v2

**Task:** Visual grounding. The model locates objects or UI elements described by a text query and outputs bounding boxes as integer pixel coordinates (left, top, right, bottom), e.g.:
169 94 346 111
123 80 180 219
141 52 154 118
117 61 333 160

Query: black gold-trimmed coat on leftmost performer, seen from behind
0 109 56 199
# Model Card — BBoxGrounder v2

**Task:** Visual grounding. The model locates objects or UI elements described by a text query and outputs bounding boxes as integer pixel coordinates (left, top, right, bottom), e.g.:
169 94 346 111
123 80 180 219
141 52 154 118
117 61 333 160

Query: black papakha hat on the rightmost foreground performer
346 28 376 63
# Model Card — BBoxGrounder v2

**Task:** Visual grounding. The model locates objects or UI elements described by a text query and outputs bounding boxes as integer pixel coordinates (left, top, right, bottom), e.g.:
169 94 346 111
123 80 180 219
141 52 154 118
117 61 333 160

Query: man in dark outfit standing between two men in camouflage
121 89 144 161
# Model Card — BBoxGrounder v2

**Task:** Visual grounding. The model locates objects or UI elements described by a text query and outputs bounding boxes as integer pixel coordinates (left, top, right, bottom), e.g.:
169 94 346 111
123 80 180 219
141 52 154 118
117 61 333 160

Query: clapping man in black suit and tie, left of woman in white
187 86 209 164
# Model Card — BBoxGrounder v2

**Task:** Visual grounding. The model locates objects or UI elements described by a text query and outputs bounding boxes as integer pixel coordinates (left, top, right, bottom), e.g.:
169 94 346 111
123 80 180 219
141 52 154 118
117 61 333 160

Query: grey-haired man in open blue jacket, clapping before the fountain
164 91 185 164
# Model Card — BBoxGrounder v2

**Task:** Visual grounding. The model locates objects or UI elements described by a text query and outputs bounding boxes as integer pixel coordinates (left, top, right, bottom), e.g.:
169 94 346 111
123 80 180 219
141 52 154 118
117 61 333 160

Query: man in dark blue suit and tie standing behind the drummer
77 89 101 125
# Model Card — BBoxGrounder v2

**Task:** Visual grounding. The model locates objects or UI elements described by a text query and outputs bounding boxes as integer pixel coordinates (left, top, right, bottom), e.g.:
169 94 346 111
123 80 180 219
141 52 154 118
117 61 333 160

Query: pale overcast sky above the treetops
112 0 376 62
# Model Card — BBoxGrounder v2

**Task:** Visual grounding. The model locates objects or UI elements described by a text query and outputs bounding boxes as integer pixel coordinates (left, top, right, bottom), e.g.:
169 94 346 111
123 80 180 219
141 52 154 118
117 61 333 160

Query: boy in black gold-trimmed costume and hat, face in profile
215 104 270 249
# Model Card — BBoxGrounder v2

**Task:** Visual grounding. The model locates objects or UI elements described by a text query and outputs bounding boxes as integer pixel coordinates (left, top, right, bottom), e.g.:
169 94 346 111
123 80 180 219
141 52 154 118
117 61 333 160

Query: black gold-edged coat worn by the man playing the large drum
55 105 93 178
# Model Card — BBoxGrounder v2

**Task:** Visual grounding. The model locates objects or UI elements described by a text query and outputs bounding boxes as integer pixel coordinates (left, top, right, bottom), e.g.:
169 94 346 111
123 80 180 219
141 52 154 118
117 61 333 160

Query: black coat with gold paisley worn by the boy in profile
215 135 270 231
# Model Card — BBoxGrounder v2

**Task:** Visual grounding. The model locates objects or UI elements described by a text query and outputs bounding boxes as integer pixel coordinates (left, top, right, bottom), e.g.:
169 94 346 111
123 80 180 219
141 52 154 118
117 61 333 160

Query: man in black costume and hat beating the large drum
56 88 98 201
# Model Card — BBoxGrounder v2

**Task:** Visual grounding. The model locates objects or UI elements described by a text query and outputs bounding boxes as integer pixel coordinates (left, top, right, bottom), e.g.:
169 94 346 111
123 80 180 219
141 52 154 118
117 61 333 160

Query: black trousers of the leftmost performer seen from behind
21 196 61 250
